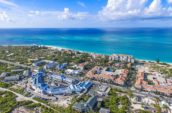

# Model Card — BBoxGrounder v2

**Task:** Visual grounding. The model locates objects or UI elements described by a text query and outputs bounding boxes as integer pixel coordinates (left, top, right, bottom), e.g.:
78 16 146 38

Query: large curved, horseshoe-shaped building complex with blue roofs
32 72 93 95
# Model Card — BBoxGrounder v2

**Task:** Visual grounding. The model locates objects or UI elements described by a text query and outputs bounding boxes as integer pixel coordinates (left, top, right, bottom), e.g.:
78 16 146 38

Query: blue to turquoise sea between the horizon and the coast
0 28 172 62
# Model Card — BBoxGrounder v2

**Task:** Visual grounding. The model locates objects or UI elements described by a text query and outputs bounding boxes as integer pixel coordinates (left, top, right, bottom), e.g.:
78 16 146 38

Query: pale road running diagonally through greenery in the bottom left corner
0 87 58 112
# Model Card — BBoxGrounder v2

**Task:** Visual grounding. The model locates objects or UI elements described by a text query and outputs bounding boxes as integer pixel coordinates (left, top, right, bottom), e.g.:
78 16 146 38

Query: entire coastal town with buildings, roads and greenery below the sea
0 45 172 113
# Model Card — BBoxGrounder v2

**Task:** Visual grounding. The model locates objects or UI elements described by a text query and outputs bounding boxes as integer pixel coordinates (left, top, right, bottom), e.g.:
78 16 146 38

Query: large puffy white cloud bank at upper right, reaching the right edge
99 0 171 20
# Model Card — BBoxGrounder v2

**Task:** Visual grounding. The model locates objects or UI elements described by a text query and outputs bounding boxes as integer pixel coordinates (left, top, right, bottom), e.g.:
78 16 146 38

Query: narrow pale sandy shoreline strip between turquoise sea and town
0 44 172 65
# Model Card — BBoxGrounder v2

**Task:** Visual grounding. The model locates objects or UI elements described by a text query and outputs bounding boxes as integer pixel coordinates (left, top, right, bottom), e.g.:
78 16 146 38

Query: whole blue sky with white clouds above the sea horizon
0 0 172 28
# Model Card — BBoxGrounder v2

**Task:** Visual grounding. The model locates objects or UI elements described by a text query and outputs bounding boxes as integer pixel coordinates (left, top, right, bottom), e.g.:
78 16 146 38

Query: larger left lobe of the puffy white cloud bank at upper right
99 0 147 20
